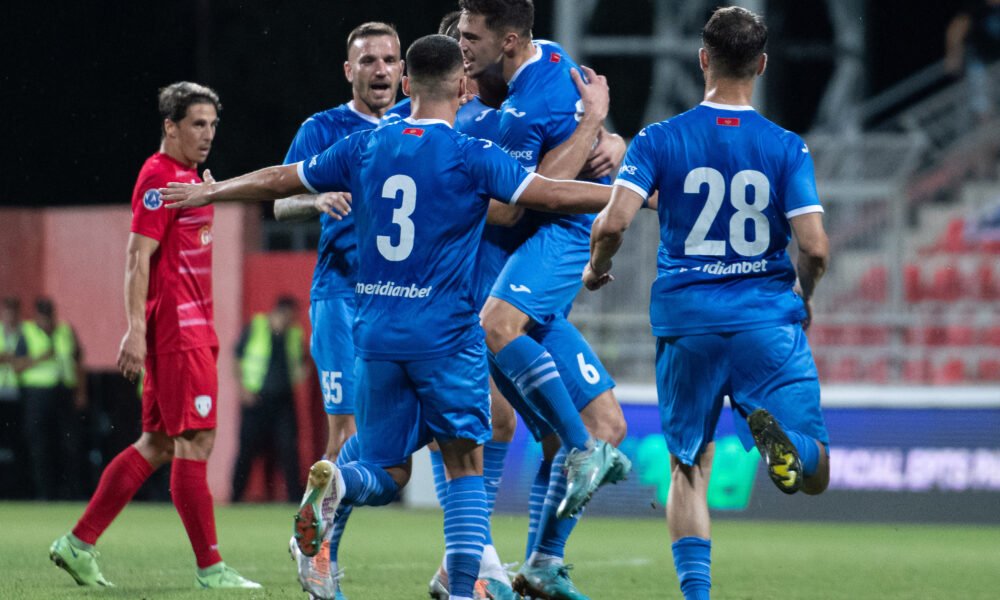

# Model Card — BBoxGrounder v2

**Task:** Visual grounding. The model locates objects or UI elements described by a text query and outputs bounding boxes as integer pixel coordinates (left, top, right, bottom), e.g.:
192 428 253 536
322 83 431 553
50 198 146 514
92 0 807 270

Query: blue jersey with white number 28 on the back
615 102 823 336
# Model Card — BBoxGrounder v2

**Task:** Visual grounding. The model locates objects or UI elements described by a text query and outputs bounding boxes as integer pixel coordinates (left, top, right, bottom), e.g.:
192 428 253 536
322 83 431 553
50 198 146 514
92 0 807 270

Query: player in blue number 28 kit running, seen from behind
584 7 830 600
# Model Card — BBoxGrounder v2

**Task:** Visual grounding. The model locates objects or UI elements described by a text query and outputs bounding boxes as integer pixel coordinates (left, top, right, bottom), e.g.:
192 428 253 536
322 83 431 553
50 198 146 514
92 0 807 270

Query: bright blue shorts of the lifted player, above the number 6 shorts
490 221 590 324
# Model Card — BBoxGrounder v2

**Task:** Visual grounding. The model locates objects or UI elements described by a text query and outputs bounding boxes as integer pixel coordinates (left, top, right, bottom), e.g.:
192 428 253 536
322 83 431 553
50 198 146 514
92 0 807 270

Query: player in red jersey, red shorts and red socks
49 82 261 588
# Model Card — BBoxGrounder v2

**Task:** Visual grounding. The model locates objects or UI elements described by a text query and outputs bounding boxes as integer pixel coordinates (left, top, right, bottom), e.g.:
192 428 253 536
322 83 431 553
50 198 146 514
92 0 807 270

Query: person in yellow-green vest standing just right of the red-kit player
232 296 303 502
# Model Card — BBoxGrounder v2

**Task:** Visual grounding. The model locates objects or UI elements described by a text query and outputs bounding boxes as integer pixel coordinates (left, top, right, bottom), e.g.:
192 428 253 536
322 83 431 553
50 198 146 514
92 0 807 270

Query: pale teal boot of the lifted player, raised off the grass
556 440 632 519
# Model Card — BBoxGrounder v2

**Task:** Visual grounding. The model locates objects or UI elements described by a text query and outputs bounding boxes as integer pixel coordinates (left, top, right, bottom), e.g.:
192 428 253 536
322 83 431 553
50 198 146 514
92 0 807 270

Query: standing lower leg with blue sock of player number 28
667 442 715 600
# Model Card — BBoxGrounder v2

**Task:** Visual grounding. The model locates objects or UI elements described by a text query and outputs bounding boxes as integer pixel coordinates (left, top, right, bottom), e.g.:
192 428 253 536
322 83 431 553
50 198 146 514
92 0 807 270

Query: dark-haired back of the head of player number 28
701 6 767 79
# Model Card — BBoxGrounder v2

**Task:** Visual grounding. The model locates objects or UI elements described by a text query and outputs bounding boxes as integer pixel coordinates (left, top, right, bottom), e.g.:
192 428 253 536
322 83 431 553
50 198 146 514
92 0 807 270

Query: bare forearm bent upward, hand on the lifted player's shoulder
536 67 610 179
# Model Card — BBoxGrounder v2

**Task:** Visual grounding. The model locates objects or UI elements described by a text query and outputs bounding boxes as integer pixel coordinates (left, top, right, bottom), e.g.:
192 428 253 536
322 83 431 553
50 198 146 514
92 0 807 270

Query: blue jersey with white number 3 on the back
299 119 531 360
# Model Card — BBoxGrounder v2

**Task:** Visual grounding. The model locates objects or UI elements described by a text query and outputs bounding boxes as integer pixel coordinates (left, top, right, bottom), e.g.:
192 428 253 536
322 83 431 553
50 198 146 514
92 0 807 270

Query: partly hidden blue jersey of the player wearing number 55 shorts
285 101 379 300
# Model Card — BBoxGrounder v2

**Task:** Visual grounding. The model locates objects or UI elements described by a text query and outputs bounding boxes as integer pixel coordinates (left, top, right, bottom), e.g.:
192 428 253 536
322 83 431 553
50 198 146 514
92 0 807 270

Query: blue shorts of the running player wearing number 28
656 324 830 465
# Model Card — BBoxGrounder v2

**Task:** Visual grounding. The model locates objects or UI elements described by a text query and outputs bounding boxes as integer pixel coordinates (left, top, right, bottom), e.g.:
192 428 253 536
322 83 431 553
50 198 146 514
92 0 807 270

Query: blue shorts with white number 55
309 296 355 415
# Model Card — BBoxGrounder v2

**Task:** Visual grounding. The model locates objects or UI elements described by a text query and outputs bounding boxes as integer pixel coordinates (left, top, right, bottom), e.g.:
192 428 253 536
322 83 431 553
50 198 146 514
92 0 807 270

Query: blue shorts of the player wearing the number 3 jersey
355 342 493 467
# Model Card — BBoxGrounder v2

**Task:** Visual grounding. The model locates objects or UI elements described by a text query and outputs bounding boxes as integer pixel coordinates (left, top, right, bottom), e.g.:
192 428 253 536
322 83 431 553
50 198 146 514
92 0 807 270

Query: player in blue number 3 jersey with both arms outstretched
164 35 608 600
